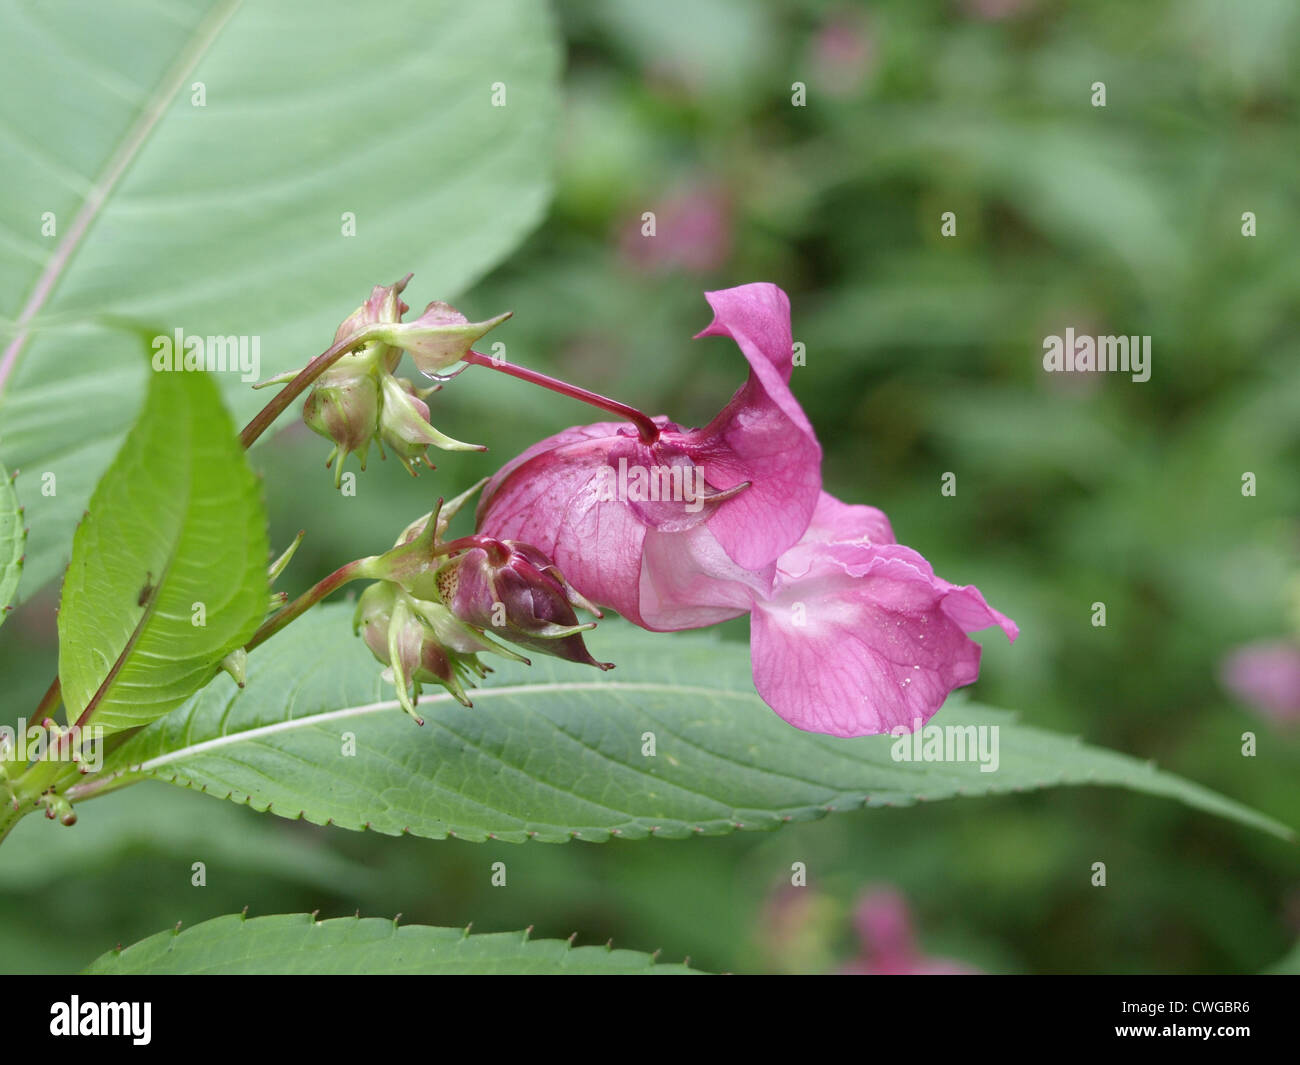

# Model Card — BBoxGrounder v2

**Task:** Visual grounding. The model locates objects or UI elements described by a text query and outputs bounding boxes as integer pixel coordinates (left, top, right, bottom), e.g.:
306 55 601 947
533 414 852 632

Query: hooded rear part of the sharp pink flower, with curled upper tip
478 283 822 629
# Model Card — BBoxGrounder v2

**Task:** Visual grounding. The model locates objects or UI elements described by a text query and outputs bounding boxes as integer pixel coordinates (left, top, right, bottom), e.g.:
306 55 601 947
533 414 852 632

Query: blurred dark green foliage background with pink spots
0 0 1300 973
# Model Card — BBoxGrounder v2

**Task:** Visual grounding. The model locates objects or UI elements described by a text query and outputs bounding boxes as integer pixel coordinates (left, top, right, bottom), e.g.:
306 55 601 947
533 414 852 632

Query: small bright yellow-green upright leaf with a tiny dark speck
59 361 269 733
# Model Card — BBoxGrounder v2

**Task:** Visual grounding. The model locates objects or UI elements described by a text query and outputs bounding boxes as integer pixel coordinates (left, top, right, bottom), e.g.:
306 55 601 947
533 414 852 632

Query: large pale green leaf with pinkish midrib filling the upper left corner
0 0 559 608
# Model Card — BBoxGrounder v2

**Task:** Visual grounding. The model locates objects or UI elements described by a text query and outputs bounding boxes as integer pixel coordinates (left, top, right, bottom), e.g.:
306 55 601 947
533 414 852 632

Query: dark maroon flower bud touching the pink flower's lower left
434 537 612 670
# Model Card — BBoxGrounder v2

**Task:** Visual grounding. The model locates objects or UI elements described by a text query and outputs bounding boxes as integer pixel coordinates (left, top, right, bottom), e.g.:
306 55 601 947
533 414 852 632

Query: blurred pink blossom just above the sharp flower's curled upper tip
619 185 732 274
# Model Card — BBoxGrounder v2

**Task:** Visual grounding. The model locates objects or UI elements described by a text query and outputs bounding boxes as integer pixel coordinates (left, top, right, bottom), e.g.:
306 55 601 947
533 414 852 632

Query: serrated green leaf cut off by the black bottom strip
86 913 696 977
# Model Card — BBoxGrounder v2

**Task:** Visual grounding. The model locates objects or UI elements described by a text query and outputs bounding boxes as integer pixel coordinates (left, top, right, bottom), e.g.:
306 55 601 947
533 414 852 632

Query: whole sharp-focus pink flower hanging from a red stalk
478 285 1018 736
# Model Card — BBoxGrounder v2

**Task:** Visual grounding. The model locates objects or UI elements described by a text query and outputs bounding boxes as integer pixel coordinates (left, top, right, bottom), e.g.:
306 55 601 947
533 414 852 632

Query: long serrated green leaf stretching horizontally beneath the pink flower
81 605 1288 841
